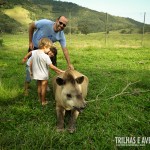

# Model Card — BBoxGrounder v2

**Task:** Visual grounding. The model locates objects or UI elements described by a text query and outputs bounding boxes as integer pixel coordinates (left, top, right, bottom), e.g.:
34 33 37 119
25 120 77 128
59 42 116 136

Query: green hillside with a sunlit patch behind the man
0 0 150 34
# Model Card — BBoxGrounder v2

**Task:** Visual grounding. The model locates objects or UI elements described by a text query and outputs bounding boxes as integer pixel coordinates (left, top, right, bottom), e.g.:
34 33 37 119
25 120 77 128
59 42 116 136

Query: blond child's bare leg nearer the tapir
41 80 48 105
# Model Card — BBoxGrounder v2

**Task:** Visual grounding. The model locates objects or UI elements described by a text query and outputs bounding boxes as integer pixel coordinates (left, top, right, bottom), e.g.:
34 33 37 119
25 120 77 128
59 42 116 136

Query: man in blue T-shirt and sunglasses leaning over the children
29 16 73 69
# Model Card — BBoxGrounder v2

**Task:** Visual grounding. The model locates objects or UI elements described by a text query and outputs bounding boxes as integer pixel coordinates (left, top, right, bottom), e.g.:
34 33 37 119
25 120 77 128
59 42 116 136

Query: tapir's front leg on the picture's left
56 106 65 131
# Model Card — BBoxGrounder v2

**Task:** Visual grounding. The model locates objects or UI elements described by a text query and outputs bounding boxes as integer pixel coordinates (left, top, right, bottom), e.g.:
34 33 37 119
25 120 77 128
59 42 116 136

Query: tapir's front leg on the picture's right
68 110 79 133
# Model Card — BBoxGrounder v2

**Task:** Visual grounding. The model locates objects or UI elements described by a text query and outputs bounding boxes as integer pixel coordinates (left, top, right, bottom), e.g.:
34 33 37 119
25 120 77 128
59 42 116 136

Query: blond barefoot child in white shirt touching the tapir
30 38 64 105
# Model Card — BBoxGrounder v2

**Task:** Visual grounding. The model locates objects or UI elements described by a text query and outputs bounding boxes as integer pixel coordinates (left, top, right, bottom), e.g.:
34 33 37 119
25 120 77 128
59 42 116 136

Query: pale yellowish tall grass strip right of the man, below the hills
68 32 150 48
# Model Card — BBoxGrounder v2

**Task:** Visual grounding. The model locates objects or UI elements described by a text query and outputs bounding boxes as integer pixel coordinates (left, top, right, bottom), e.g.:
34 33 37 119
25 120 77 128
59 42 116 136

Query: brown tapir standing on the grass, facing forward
52 70 89 133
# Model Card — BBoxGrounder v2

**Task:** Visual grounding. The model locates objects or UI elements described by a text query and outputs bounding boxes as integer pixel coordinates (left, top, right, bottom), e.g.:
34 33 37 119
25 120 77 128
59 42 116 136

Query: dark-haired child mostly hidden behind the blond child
22 43 57 96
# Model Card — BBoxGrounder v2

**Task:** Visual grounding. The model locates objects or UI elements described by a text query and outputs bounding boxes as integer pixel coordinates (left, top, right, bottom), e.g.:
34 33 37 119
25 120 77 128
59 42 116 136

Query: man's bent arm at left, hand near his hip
29 22 36 50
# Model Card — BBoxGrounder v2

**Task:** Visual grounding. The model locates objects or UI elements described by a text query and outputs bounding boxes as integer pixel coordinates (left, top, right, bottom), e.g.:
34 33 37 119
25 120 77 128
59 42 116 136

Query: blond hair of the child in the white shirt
38 38 53 48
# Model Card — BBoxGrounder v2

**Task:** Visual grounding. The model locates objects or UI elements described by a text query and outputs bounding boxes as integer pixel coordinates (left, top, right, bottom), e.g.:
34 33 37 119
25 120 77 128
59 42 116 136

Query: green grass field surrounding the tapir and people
0 34 150 150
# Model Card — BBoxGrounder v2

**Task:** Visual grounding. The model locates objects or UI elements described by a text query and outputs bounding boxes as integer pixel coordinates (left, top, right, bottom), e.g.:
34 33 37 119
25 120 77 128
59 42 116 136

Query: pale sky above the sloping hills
60 0 150 24
